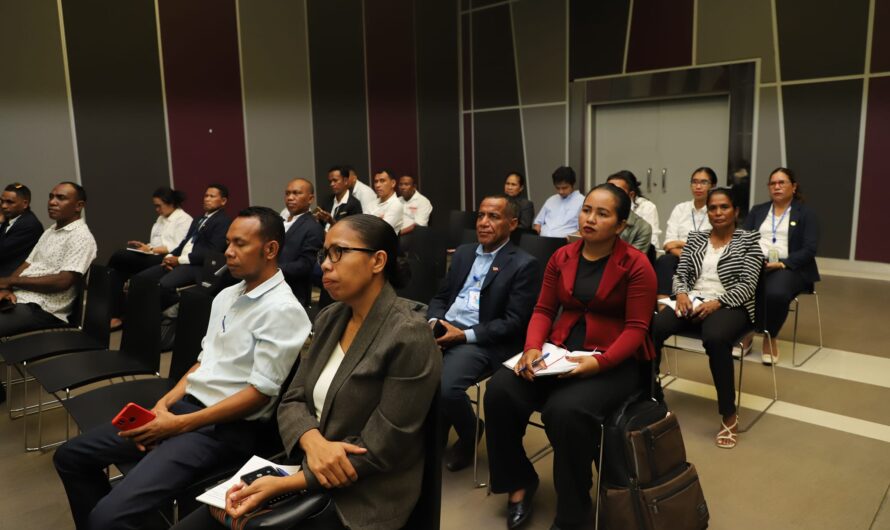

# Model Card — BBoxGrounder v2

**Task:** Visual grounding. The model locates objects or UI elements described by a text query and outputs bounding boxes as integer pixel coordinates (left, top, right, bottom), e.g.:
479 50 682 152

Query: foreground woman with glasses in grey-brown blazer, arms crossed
177 214 442 530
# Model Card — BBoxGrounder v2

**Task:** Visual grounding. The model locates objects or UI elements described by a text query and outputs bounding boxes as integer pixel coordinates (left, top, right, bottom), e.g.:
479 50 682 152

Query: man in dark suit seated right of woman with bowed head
137 184 232 309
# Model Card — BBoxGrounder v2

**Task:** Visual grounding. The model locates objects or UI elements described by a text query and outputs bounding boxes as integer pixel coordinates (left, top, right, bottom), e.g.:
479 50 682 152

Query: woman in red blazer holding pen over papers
485 184 656 528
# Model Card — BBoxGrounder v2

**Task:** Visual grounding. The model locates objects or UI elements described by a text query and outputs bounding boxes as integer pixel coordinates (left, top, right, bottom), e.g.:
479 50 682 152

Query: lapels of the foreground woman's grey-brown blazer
313 283 397 430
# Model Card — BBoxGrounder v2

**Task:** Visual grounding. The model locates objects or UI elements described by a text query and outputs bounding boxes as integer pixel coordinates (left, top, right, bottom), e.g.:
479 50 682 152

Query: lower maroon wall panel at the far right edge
856 77 890 263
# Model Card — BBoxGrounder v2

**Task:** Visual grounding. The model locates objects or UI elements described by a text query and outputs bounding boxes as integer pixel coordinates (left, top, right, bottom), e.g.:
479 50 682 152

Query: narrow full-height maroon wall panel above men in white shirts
365 0 417 177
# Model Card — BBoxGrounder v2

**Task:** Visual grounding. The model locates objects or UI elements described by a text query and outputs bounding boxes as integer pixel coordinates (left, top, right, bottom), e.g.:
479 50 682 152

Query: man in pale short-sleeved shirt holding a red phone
53 207 311 529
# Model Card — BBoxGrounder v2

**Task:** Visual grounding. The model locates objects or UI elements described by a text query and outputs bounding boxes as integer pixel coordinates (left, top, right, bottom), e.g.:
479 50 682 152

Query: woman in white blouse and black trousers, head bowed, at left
108 186 192 328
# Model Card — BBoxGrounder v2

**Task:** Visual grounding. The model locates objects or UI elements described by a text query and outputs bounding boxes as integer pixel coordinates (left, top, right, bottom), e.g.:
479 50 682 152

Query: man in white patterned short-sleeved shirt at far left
0 182 96 337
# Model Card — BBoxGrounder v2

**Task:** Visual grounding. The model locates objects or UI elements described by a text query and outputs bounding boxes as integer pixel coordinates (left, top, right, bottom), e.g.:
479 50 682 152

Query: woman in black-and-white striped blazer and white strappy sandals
652 188 763 449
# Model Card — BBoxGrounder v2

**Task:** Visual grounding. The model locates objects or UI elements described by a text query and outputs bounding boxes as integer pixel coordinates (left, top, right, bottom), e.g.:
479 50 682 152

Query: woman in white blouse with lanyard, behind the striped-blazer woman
655 167 717 298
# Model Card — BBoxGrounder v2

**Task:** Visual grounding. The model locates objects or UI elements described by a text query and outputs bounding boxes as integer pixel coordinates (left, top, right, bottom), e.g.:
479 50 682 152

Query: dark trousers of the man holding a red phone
53 400 256 530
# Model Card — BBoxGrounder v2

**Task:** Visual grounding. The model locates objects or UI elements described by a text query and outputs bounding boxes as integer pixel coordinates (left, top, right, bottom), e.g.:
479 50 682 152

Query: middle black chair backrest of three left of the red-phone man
121 275 161 369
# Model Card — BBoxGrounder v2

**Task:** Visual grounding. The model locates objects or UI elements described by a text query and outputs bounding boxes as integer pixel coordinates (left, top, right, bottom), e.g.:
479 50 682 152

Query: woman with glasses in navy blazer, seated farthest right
744 167 819 364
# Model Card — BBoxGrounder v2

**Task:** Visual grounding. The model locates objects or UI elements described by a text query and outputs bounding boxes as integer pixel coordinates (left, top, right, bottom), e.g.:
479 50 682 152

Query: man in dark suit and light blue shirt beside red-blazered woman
427 196 541 471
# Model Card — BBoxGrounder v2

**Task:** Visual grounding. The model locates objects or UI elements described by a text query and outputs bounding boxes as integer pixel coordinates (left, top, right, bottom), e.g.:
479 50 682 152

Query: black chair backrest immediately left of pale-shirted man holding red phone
169 289 213 381
